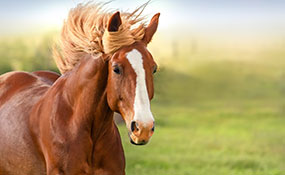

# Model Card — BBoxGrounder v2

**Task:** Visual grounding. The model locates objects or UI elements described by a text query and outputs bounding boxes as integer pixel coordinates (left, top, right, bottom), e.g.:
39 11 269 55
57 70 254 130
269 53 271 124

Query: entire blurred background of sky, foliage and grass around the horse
0 0 285 175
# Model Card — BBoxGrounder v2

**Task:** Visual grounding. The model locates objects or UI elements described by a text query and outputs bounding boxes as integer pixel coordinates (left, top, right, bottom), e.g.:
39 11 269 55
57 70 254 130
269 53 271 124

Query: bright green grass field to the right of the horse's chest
119 105 285 175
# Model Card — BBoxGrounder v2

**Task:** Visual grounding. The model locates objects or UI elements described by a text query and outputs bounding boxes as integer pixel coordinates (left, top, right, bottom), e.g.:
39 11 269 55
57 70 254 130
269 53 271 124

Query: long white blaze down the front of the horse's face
127 49 154 123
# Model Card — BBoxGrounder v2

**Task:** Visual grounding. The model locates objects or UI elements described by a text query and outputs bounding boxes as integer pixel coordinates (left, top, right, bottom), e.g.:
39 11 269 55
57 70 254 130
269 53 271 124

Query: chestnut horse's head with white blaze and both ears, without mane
107 12 159 145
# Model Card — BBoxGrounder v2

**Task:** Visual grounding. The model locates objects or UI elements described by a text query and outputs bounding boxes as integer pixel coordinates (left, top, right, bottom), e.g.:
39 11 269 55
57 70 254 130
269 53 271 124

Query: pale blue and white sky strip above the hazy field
0 0 285 36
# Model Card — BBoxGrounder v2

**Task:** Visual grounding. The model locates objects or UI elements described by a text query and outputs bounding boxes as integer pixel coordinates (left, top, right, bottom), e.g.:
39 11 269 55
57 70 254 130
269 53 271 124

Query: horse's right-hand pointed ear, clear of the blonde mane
142 13 160 44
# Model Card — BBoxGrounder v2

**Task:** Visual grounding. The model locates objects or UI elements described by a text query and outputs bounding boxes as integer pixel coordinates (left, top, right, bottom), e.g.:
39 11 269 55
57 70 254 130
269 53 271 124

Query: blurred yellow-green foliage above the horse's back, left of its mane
0 32 58 74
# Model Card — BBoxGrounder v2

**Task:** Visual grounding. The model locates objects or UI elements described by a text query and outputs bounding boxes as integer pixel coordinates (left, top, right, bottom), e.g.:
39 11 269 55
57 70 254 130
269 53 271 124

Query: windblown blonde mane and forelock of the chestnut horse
53 3 148 74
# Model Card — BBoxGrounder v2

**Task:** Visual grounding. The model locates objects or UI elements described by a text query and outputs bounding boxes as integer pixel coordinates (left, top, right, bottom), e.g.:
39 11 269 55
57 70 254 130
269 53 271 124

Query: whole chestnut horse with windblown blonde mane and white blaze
0 3 160 175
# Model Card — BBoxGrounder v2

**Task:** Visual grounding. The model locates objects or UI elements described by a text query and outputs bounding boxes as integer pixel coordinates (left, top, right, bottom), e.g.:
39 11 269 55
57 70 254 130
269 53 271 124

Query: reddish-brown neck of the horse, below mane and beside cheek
62 56 114 141
